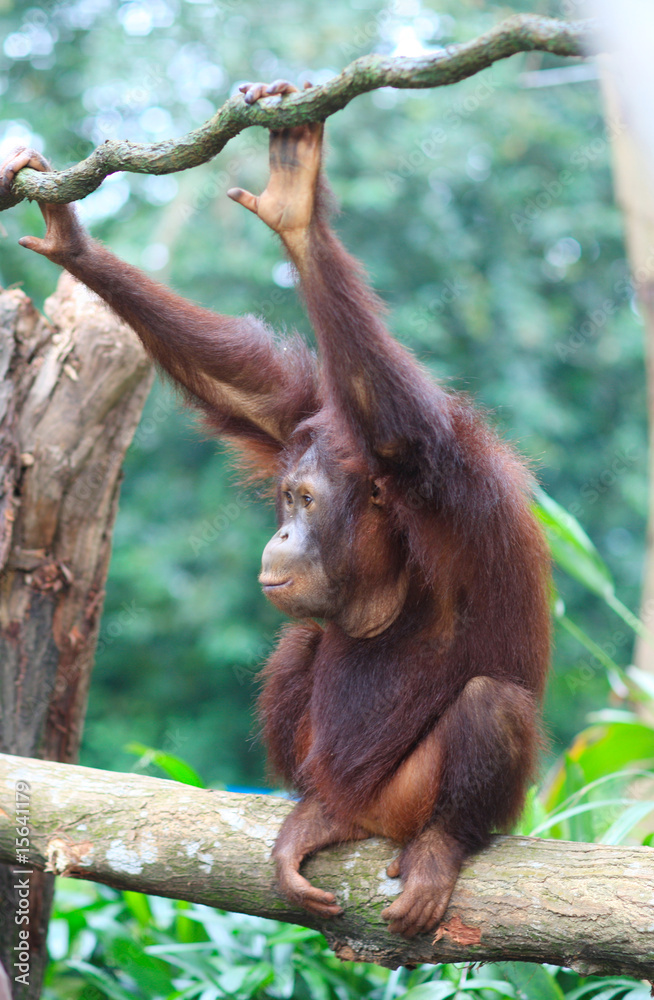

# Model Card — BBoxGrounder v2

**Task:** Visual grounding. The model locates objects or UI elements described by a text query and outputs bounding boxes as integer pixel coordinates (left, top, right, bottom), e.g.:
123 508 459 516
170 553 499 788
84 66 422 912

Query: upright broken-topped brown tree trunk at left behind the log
0 275 151 1000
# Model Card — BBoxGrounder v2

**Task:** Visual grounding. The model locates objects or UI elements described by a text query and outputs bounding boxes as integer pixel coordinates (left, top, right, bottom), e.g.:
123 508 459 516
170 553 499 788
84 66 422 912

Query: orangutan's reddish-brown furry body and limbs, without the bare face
0 130 549 934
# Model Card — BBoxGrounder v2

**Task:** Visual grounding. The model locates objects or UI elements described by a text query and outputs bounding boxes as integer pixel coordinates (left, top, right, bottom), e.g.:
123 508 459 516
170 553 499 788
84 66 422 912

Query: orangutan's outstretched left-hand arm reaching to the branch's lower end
0 150 317 453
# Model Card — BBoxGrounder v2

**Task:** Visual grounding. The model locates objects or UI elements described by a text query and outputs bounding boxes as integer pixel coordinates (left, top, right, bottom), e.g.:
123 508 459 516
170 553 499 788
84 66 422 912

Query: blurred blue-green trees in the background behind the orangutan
0 0 647 786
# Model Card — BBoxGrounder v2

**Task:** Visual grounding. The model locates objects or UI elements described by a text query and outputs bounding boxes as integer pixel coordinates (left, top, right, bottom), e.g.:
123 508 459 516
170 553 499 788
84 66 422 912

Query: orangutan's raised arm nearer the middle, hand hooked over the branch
229 81 455 471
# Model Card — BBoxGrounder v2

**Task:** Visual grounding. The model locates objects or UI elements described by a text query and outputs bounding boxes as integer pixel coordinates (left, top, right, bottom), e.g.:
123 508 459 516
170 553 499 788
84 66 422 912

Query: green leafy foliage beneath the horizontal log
43 880 649 1000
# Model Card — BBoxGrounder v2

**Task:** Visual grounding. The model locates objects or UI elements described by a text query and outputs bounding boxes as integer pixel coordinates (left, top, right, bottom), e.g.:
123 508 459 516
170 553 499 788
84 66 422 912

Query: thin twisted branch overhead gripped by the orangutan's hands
0 14 594 211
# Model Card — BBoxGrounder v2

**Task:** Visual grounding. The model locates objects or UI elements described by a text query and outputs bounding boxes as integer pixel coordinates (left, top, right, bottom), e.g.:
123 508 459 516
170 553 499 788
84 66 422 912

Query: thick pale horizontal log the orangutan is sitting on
0 755 654 978
